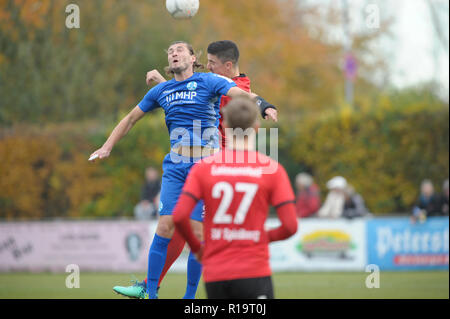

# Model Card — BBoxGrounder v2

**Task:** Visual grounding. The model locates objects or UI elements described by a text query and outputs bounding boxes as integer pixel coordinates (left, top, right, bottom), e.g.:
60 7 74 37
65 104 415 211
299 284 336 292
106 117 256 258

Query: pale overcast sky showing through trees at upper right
300 0 449 100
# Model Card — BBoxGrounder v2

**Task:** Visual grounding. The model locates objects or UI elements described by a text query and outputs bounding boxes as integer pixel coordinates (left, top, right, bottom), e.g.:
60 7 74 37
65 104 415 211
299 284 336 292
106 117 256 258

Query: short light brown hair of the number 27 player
222 97 259 131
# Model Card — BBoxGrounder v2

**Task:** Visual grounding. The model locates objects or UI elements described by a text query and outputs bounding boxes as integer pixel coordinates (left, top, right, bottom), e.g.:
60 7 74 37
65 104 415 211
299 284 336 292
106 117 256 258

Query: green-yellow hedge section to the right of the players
282 89 449 213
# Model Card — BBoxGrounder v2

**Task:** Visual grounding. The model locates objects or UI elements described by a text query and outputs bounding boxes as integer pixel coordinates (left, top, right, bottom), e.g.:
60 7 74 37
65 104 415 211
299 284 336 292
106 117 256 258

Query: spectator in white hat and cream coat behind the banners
317 176 347 218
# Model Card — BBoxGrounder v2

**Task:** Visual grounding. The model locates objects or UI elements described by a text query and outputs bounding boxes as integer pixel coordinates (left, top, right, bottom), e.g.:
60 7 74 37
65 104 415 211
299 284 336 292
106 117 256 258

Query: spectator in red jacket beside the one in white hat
295 173 320 218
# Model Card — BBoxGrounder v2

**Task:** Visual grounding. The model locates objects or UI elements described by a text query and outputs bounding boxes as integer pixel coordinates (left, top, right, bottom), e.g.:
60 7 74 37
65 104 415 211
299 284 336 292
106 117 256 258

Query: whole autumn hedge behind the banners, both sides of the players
0 90 449 219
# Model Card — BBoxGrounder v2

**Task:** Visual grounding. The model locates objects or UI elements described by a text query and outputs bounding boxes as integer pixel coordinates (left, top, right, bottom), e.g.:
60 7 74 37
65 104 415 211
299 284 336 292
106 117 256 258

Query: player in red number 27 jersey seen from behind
173 98 297 299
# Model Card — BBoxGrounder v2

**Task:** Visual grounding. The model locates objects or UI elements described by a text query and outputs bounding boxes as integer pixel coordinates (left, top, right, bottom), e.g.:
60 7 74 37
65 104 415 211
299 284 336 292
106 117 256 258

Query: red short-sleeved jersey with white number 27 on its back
178 149 295 282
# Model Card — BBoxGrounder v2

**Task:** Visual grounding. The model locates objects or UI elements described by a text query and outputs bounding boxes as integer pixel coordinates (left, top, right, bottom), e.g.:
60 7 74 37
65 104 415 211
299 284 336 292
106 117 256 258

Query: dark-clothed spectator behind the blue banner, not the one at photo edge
411 179 442 223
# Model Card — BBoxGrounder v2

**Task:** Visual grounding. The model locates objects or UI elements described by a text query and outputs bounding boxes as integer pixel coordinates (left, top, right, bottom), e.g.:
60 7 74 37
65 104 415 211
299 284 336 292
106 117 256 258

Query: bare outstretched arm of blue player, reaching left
90 106 145 160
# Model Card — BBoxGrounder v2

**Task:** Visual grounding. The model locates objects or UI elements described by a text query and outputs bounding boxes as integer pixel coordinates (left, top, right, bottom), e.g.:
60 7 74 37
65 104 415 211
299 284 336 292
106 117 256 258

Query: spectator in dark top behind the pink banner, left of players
134 167 161 220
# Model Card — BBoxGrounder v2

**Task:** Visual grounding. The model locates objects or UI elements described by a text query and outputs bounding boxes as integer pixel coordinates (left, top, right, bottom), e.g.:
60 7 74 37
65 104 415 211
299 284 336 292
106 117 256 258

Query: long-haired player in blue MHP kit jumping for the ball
91 42 276 299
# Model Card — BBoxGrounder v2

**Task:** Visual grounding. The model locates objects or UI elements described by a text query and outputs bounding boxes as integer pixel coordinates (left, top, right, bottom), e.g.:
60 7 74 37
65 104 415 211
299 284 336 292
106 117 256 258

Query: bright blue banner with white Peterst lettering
367 217 449 270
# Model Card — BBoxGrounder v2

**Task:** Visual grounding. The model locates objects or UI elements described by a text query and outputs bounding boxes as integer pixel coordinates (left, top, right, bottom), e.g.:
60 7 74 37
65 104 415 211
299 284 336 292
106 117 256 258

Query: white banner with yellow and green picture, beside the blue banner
267 219 367 272
